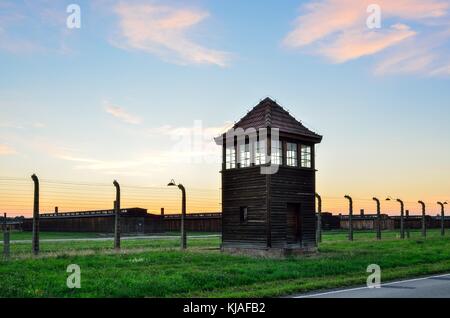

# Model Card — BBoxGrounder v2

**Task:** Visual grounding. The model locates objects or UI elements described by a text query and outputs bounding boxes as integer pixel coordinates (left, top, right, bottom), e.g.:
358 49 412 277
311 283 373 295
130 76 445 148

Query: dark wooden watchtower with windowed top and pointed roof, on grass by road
216 98 322 255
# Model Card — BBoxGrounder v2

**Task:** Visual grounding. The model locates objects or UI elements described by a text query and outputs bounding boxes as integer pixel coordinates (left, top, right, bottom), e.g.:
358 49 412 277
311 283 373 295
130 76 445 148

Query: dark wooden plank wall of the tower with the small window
222 167 267 247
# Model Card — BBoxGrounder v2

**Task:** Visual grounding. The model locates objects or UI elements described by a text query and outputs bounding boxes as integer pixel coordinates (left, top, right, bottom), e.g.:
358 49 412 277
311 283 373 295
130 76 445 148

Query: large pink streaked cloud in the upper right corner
283 0 450 75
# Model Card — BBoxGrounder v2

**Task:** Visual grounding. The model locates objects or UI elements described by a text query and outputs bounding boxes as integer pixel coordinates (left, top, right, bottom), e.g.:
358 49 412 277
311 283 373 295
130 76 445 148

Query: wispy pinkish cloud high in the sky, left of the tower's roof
112 2 230 67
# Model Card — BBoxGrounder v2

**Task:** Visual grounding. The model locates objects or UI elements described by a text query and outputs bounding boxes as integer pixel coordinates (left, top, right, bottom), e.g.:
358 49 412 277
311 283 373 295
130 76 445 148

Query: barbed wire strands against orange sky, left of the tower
0 178 221 217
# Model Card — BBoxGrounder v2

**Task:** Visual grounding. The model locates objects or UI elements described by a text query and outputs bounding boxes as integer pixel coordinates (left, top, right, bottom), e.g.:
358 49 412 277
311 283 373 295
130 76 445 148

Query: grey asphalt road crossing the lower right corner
293 274 450 298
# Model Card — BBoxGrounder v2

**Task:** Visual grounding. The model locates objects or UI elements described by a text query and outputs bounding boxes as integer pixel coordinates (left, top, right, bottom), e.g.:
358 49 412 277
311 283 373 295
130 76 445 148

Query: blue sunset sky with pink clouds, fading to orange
0 0 450 215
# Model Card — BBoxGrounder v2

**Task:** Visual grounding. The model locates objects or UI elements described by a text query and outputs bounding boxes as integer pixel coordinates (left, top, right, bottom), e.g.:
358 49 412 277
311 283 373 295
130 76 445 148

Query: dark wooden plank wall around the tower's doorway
271 166 316 247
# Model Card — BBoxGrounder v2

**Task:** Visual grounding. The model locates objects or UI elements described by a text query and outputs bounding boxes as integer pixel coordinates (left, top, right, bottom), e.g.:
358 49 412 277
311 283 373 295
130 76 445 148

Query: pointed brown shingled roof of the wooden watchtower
233 97 322 141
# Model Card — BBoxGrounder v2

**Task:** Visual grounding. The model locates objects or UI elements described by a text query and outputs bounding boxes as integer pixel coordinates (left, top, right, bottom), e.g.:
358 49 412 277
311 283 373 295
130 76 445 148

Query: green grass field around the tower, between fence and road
0 231 450 297
